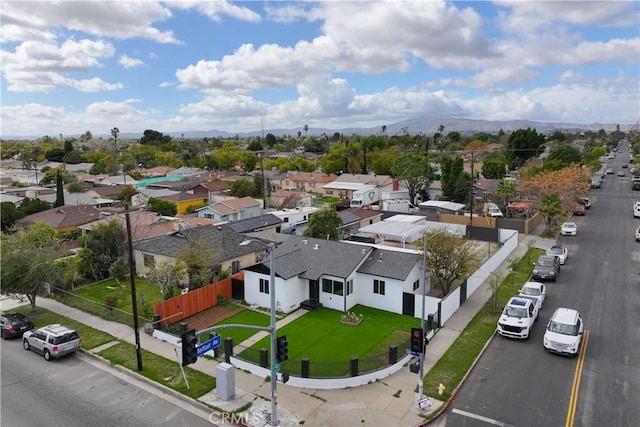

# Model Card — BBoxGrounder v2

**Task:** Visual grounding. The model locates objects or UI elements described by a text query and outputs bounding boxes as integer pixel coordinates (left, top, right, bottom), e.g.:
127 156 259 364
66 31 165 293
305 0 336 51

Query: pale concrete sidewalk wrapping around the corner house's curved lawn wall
3 231 555 427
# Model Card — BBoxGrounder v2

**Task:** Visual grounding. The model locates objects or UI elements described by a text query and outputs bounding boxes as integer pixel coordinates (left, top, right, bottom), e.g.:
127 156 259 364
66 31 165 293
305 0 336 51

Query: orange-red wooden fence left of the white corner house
153 273 244 323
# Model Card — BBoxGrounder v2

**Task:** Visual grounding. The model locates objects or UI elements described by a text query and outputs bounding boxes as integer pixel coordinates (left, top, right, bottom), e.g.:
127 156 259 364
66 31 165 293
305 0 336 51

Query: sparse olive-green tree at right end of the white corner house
420 229 479 297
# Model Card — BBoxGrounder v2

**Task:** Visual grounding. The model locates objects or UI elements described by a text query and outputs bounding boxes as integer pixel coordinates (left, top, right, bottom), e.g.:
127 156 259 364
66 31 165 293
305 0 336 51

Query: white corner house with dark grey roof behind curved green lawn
244 236 421 314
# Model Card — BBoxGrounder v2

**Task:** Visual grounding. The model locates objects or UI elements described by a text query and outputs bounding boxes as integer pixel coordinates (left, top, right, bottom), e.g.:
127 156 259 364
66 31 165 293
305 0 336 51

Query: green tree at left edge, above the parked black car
0 222 63 310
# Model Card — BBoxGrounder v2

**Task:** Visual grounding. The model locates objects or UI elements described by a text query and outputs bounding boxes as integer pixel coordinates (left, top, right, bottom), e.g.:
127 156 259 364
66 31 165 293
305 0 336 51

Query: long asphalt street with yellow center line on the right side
440 145 640 427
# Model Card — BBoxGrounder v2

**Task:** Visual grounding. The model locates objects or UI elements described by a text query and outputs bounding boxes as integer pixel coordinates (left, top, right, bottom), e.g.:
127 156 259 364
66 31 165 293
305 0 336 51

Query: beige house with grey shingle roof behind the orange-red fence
133 225 265 275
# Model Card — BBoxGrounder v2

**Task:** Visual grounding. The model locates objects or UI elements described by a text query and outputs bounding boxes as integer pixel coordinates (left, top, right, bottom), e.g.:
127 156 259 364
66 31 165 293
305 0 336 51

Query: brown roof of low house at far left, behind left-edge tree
16 205 118 233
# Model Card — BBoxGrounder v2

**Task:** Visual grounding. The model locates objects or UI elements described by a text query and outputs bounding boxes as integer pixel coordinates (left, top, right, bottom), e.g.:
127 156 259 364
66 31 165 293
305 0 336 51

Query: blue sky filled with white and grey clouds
0 0 640 137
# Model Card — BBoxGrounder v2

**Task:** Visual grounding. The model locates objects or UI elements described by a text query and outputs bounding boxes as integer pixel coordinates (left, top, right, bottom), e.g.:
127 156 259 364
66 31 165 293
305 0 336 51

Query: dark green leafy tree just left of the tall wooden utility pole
78 220 126 280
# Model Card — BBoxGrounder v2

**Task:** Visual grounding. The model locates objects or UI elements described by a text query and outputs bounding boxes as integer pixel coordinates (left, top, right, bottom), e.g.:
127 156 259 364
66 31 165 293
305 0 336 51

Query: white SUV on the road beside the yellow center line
543 308 584 356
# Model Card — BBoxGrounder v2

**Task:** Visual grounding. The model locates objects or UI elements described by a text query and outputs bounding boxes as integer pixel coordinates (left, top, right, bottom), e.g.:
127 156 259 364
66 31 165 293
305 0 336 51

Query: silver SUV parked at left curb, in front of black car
22 323 81 361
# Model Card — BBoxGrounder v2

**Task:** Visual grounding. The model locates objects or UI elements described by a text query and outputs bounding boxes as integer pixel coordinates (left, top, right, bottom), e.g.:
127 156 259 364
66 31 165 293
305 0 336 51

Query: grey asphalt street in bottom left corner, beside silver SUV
0 339 212 427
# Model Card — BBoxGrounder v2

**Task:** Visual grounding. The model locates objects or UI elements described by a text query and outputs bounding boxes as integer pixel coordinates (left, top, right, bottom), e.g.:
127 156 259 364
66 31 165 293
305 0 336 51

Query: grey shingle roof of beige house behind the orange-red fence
133 225 264 263
